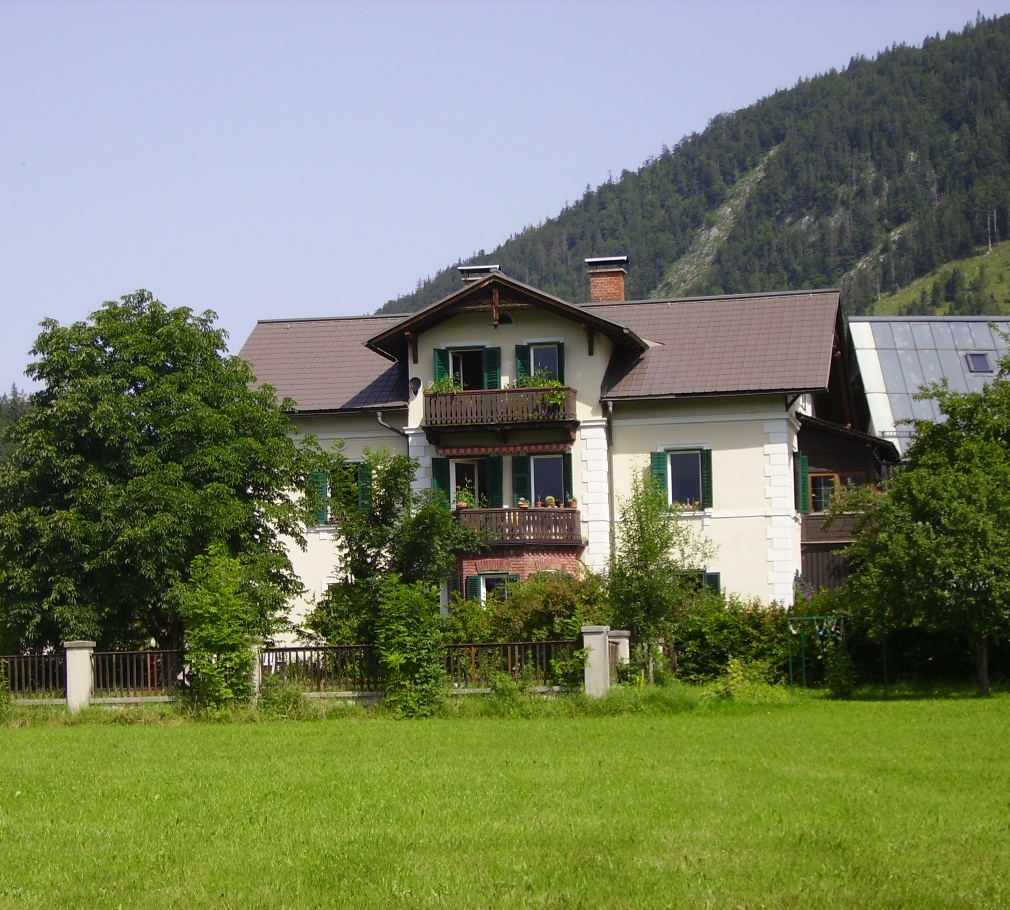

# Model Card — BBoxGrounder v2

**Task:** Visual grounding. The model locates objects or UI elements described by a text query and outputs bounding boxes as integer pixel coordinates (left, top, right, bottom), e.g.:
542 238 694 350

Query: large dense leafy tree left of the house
0 291 320 649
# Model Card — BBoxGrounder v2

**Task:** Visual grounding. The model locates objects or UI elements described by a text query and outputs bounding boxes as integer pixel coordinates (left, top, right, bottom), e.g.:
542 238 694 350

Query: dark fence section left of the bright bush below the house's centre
260 644 382 692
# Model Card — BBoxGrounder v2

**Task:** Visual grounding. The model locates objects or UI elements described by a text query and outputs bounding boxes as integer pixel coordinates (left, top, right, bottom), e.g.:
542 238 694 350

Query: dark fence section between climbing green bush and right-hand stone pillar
445 641 583 689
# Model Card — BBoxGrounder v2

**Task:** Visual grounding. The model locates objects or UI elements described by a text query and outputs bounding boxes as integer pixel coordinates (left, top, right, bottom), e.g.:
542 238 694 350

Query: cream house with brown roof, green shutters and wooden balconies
240 257 876 626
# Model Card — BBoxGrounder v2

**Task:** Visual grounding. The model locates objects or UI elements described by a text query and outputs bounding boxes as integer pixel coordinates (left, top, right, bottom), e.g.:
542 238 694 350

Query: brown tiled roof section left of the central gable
238 315 407 412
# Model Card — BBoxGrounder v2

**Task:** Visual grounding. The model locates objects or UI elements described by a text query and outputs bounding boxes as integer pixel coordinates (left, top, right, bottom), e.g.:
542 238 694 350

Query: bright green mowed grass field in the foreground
0 696 1010 910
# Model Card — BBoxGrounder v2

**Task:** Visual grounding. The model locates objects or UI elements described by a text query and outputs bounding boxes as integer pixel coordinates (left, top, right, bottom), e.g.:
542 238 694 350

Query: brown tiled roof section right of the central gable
585 291 838 399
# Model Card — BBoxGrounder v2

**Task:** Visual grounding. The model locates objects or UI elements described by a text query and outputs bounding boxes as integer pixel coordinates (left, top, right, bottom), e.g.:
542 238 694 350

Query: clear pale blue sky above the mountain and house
0 0 1010 390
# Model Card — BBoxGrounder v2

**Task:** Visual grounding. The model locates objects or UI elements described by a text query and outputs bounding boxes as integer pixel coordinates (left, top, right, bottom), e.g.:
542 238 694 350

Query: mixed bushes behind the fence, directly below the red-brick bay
445 571 609 644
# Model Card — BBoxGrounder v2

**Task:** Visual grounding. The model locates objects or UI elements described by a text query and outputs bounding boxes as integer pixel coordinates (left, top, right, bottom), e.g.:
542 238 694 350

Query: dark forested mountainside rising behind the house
382 16 1010 313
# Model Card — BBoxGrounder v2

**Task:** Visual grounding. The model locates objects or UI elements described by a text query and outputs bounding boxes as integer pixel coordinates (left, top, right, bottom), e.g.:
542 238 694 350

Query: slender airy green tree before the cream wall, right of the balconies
608 471 715 669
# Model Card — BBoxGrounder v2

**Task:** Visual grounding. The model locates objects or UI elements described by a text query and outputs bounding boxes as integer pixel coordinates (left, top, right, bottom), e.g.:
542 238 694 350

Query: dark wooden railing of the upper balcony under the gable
424 388 576 427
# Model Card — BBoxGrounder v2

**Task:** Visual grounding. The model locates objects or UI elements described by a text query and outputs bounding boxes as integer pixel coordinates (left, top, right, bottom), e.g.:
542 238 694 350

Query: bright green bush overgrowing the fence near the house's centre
376 576 445 717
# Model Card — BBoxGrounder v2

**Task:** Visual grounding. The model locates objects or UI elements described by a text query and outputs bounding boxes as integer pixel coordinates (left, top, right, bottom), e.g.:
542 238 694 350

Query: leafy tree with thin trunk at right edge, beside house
834 360 1010 695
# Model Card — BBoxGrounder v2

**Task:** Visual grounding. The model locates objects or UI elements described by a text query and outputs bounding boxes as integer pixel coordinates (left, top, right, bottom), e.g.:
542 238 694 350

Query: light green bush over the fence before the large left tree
176 544 262 709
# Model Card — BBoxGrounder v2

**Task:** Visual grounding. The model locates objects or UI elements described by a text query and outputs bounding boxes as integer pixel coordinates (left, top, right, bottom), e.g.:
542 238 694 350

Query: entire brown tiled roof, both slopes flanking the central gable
239 291 838 412
